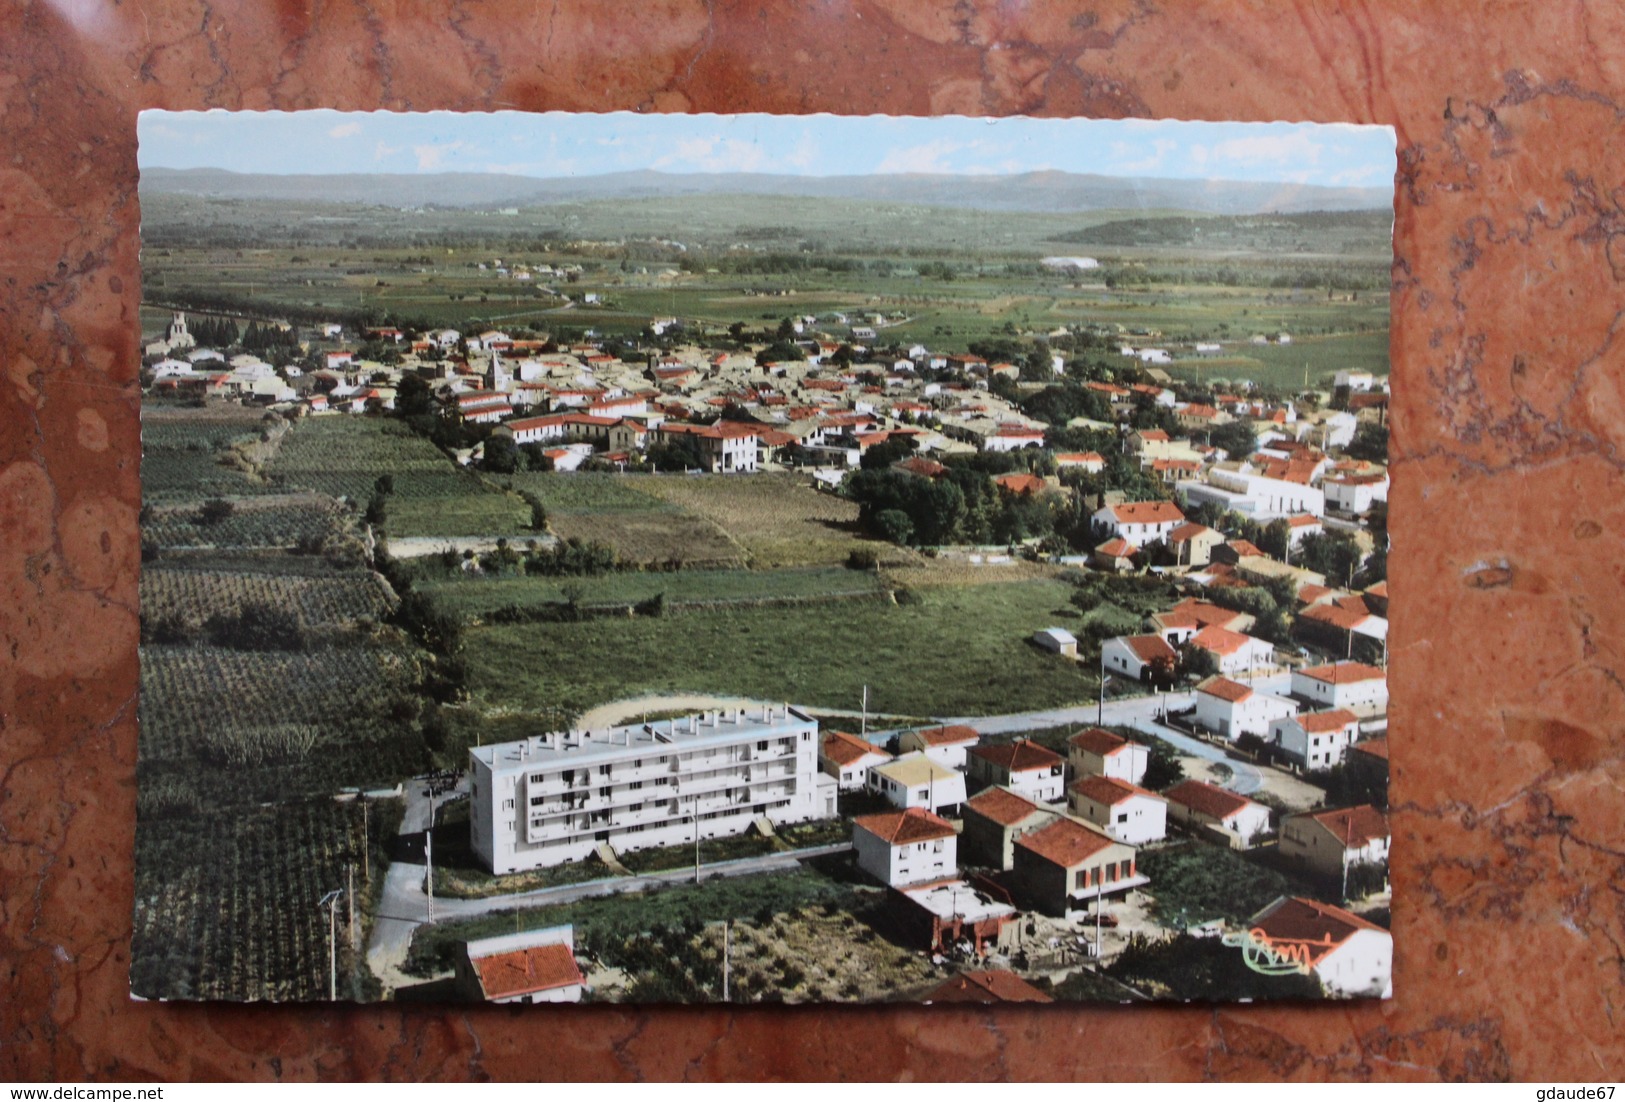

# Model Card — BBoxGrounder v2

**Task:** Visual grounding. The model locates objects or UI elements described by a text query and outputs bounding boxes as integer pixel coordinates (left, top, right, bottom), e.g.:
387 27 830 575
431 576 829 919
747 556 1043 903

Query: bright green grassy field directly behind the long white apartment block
466 580 1095 715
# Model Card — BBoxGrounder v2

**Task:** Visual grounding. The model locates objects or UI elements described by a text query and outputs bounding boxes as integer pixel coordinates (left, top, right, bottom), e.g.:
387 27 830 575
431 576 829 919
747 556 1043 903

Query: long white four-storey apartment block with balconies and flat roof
468 705 837 873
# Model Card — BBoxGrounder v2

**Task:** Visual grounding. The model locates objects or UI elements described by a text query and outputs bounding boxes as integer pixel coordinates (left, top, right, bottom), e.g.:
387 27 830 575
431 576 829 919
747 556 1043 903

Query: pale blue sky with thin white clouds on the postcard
138 111 1394 187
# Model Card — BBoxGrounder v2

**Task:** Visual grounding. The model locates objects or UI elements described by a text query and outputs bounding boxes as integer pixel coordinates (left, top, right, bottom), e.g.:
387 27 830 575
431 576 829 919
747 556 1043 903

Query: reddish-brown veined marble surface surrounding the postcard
0 0 1625 1081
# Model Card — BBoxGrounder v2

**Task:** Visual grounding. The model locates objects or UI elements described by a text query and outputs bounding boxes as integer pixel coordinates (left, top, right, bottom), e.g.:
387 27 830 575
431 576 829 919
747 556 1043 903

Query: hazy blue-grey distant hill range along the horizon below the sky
141 167 1393 215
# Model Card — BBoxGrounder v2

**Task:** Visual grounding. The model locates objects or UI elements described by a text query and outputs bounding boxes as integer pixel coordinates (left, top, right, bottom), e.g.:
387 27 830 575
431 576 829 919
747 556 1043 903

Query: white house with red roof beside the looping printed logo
1248 896 1394 998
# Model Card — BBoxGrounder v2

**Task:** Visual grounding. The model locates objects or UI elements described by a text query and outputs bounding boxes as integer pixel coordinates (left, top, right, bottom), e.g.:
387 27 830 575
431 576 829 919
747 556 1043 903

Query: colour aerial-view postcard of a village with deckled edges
130 111 1396 1004
